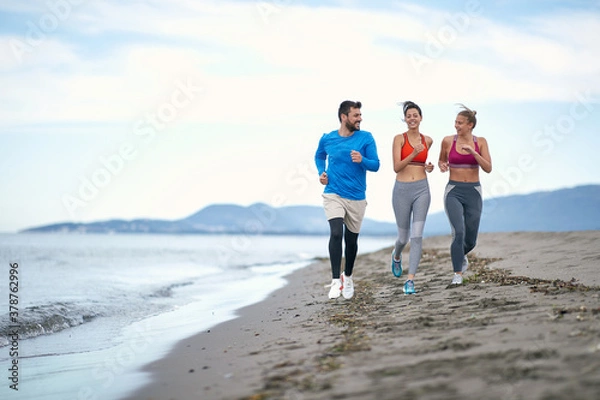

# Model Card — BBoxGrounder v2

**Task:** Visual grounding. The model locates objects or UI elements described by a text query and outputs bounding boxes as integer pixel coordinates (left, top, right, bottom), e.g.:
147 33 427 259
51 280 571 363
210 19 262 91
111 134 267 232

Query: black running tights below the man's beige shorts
329 218 358 279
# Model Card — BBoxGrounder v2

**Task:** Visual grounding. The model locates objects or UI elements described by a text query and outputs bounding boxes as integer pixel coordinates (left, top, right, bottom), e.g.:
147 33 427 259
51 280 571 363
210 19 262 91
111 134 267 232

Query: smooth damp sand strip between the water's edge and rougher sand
123 255 331 400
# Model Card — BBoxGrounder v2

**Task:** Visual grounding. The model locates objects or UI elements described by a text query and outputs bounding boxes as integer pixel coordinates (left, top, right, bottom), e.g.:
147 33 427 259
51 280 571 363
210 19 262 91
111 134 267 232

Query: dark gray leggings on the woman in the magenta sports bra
444 181 483 272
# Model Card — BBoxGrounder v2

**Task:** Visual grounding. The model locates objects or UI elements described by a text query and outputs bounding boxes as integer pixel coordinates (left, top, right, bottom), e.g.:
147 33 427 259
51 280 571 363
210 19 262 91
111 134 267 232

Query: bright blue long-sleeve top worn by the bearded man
315 130 380 200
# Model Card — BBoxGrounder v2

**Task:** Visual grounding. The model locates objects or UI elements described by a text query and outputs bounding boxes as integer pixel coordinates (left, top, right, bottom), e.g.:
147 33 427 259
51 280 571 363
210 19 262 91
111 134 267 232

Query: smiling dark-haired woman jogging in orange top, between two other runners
392 101 433 294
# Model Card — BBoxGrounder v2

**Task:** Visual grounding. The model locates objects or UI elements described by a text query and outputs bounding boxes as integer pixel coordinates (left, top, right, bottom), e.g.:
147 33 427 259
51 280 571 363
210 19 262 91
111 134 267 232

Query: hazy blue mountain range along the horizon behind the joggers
22 185 600 236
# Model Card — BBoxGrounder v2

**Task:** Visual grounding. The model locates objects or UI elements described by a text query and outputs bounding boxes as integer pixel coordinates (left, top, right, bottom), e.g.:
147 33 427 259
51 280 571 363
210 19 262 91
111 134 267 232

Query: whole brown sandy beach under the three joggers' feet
127 231 600 400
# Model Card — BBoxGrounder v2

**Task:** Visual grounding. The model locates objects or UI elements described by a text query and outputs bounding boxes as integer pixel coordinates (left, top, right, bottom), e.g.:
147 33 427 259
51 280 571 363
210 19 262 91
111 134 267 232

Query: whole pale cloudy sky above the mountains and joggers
0 0 600 232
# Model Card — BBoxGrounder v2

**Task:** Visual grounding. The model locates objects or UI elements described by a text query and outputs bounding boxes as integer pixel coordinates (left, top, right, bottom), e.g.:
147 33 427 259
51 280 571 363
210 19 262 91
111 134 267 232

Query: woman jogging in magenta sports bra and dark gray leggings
438 104 492 285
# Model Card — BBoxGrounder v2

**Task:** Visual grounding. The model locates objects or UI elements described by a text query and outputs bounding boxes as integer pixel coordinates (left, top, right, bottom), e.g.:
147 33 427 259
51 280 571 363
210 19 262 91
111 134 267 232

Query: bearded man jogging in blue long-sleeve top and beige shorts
315 100 379 299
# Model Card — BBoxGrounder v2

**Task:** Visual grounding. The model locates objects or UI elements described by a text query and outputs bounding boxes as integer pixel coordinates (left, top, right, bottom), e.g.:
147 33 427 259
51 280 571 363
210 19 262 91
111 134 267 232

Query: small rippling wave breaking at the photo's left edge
0 302 102 347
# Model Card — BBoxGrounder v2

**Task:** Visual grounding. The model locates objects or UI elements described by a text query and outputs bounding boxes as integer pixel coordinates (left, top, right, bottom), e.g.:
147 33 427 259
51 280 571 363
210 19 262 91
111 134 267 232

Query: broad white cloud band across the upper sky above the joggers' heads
0 0 600 128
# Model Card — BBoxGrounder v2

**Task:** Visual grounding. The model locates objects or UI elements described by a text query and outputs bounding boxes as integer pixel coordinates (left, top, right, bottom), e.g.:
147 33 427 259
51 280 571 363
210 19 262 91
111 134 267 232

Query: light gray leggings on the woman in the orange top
392 178 431 275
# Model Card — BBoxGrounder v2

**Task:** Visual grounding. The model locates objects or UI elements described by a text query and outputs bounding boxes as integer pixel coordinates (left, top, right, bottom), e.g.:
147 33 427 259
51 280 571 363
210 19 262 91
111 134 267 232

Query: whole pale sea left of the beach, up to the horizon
0 234 394 400
